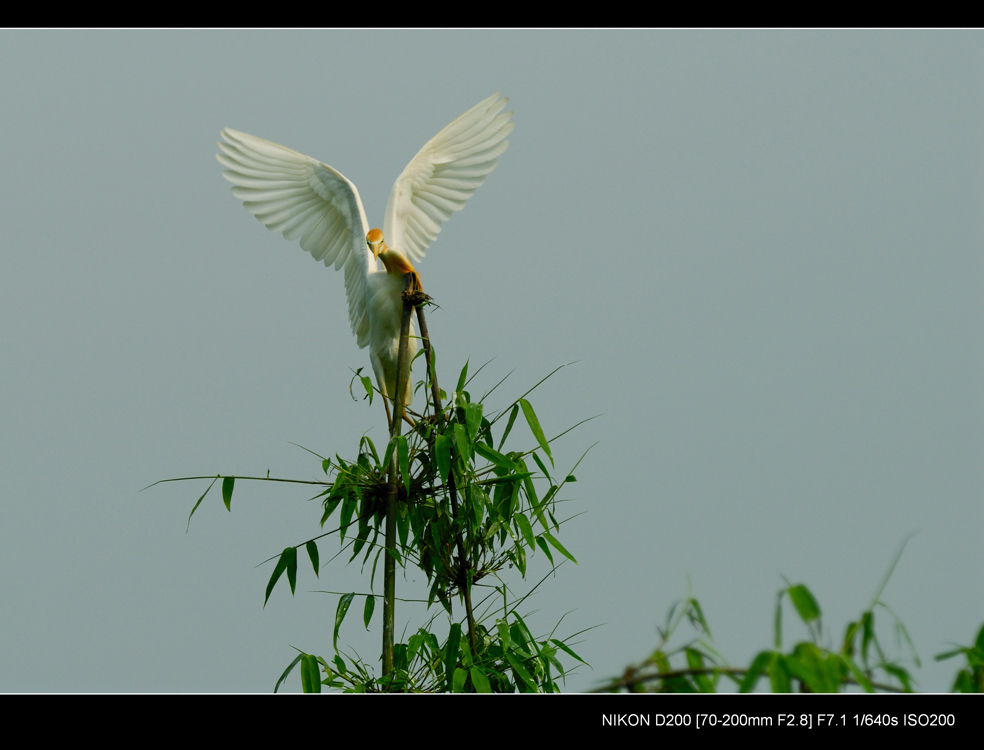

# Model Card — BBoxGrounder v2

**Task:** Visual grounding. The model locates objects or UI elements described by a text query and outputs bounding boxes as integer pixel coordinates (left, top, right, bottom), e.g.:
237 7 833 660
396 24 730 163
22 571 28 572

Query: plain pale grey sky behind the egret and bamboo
0 30 984 691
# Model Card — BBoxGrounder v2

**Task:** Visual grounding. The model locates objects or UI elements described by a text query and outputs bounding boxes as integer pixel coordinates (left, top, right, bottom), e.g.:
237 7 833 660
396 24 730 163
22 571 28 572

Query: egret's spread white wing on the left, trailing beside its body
215 128 375 347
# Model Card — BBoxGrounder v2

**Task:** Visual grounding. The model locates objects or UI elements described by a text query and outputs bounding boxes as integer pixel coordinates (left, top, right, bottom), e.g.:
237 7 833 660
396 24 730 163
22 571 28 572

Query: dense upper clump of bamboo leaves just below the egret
320 364 577 611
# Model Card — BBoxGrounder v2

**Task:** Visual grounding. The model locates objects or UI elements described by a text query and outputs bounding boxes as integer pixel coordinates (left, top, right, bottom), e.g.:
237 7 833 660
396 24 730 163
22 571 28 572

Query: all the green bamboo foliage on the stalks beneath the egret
167 363 584 692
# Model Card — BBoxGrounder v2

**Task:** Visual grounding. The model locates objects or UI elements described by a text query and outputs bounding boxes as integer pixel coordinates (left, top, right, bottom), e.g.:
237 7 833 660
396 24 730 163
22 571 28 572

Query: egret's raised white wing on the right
383 93 513 261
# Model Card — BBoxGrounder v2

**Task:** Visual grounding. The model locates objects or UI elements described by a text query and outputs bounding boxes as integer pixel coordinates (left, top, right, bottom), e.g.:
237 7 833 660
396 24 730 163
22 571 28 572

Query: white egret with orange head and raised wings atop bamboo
216 93 513 418
